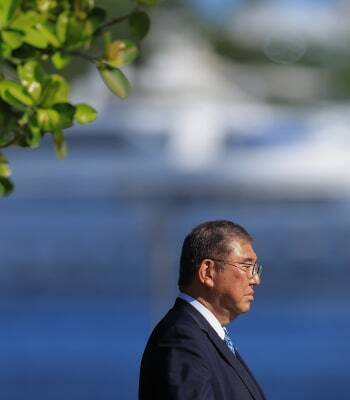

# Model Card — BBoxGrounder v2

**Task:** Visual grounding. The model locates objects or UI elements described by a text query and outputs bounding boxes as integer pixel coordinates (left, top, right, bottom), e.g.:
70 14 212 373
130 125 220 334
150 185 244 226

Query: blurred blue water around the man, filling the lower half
0 199 350 400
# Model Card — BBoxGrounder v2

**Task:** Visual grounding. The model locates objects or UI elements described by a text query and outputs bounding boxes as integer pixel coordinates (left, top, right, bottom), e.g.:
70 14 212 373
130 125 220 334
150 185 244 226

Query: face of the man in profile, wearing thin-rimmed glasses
214 240 260 321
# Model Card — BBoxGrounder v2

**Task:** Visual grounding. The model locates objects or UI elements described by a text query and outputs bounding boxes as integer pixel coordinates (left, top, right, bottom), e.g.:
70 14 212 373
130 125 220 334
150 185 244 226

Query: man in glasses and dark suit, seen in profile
139 221 265 400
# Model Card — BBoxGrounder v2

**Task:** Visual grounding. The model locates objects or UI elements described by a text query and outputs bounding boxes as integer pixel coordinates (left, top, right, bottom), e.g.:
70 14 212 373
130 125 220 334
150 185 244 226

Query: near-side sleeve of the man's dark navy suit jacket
158 327 215 400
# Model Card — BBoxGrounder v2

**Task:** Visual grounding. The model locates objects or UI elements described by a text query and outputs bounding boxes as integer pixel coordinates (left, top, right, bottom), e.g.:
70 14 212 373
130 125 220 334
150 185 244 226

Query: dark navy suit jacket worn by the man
139 299 266 400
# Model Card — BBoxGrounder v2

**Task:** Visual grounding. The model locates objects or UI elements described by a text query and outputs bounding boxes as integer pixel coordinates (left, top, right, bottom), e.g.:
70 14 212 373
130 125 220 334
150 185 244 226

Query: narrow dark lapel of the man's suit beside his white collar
175 299 264 400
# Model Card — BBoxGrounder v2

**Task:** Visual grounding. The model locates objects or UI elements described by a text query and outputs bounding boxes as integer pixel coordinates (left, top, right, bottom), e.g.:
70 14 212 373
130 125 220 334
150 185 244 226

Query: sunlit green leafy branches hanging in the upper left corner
0 0 159 196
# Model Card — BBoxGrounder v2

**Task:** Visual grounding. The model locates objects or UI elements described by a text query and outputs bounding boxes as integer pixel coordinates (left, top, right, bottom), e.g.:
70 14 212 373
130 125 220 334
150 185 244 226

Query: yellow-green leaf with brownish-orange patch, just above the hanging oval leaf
105 40 139 68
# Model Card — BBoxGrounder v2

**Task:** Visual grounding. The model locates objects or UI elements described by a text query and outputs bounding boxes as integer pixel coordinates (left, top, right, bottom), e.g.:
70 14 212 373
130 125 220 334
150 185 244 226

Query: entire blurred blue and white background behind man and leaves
0 0 350 400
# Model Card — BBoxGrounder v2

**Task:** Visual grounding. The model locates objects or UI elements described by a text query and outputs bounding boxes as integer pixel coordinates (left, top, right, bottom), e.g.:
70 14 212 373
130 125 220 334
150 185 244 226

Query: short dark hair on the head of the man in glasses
178 220 253 289
